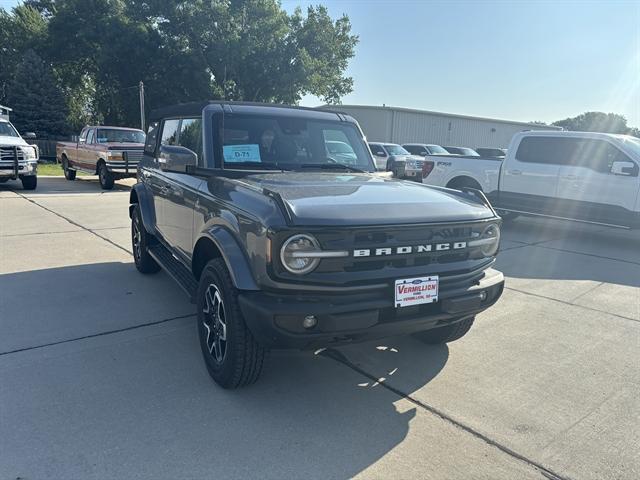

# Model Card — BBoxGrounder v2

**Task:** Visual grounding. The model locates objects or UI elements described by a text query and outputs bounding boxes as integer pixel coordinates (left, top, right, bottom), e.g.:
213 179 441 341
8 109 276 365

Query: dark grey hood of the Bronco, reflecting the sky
240 172 493 226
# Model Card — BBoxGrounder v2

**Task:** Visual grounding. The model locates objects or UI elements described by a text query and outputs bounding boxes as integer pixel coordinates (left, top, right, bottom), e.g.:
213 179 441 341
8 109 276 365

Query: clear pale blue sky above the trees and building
0 0 640 127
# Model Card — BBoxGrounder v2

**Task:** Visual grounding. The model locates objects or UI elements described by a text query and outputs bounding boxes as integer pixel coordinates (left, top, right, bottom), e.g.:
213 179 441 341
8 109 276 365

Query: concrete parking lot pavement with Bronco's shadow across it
0 177 640 479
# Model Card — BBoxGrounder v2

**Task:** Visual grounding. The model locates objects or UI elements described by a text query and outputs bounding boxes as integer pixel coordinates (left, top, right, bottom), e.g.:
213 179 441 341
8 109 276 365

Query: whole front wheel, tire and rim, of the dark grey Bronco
197 258 267 389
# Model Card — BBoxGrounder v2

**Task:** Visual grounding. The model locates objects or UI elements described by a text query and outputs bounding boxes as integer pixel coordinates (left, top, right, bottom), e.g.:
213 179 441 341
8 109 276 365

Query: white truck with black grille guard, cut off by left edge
0 118 39 190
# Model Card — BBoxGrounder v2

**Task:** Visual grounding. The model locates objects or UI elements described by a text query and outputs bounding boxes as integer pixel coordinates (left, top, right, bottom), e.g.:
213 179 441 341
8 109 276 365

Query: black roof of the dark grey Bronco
149 100 351 122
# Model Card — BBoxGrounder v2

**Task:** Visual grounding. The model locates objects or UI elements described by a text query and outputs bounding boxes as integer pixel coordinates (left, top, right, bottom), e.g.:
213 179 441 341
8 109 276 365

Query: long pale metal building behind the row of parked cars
323 105 562 148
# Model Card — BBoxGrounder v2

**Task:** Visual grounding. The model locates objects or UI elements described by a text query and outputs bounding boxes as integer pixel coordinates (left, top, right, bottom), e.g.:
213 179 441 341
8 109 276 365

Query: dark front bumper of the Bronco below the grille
238 268 504 349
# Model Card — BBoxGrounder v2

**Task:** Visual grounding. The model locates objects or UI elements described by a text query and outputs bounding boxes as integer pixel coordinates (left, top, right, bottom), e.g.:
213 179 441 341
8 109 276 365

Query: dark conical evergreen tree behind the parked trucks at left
9 50 68 137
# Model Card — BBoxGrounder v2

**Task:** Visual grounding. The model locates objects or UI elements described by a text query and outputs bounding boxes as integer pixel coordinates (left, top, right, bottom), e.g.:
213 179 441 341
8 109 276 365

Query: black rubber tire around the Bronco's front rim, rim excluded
196 258 267 389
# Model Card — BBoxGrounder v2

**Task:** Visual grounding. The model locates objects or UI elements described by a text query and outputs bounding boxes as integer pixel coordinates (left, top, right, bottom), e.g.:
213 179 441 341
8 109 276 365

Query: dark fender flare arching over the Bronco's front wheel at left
193 226 260 290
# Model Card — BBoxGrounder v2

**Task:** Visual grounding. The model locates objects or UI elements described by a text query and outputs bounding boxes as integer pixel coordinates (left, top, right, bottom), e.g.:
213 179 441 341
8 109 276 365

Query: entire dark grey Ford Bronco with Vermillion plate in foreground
129 102 504 388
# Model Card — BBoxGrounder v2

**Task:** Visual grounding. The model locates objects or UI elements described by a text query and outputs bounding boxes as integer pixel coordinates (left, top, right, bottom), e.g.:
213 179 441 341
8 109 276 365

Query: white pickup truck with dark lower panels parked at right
423 131 640 228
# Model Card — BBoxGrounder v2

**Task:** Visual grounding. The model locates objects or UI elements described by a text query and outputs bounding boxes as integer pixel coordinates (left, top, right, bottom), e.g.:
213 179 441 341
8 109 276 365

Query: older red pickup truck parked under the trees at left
56 126 145 190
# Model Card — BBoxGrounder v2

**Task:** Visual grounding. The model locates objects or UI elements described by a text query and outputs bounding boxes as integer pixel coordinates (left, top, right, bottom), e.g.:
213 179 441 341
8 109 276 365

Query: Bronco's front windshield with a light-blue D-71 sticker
221 114 374 171
